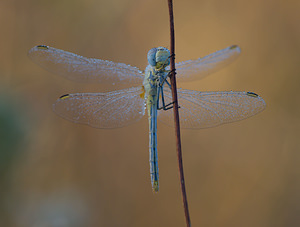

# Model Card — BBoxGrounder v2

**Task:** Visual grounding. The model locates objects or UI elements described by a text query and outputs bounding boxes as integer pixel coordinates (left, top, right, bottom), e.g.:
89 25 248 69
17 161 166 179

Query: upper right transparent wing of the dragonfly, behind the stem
168 45 241 82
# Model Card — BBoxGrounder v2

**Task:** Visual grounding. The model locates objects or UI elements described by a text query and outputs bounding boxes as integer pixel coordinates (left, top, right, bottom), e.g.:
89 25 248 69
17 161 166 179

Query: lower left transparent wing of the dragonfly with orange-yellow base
53 87 145 128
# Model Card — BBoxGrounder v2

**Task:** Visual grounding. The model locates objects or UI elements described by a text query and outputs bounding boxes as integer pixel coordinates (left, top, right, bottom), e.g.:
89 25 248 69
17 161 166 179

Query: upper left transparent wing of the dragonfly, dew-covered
28 45 143 84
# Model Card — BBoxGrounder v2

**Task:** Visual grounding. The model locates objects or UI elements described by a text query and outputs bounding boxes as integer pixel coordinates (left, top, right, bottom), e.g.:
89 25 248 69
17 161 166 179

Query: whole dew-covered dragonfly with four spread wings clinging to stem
28 45 266 192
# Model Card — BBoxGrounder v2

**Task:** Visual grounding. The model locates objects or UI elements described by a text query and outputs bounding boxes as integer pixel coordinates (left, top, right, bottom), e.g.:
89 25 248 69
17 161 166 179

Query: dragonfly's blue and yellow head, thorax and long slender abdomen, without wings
143 47 170 192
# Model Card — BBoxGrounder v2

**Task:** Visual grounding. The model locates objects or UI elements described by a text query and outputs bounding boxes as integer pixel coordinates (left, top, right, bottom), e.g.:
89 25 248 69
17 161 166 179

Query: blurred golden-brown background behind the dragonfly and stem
0 0 300 227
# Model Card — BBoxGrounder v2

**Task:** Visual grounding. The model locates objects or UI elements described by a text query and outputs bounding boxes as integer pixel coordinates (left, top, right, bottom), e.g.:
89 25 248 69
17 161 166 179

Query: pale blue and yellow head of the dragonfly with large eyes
147 47 170 69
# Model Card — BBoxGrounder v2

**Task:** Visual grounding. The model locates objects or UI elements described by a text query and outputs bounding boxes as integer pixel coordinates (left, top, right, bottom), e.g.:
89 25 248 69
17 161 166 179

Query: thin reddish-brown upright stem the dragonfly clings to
168 0 191 227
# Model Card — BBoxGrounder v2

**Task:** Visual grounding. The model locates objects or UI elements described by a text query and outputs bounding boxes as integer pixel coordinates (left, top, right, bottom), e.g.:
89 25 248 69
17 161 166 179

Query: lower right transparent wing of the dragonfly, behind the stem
158 86 266 129
